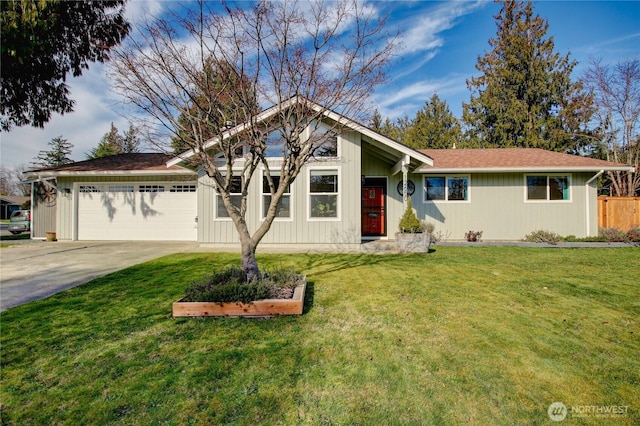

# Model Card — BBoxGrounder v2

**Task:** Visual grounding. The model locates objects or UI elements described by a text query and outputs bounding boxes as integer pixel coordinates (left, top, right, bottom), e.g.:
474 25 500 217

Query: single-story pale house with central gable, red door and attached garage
30 99 632 245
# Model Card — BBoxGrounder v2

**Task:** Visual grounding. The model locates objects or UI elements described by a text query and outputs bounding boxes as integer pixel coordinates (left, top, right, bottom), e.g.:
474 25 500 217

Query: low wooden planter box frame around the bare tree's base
173 278 307 318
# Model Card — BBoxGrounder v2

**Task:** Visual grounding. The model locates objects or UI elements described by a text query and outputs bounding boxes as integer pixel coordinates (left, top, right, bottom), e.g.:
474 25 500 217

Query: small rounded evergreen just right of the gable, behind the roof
404 94 462 149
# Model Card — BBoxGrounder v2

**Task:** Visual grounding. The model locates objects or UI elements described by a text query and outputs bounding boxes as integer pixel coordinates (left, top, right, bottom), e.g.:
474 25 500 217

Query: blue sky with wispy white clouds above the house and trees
0 0 640 168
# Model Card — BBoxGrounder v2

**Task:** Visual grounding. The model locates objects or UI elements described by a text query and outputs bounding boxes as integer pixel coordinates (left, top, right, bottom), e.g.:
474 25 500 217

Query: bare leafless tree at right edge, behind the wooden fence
584 59 640 196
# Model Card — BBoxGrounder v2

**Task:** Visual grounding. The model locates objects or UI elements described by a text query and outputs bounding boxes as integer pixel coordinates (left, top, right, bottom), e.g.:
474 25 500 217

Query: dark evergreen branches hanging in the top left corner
0 0 130 130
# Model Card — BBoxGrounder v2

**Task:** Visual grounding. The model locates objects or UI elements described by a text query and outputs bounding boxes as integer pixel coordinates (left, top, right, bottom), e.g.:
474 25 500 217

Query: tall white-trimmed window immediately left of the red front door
309 169 339 219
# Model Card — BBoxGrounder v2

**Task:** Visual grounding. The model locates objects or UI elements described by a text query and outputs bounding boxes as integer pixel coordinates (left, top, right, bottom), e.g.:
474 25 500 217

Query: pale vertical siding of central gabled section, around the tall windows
198 132 362 248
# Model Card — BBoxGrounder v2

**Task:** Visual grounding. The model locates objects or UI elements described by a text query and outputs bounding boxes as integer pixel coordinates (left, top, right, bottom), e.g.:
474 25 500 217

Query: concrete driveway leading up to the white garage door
0 241 200 311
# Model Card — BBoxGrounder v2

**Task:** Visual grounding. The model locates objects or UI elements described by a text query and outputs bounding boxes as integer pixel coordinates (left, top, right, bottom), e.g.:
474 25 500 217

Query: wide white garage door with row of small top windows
77 183 197 241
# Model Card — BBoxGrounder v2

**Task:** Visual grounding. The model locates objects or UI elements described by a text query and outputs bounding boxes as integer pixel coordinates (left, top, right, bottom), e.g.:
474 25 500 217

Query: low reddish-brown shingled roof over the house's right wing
419 148 633 173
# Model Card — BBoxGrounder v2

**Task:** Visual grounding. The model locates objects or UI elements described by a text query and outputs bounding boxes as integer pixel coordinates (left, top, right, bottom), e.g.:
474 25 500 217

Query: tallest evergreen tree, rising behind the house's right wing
463 0 591 151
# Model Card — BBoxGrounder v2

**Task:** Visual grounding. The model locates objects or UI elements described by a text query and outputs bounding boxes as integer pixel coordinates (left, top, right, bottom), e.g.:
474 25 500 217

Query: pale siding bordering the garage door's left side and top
56 176 195 240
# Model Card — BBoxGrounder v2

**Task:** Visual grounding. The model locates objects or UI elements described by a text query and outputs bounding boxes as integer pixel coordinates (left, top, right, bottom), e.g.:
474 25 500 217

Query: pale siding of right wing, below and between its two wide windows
414 173 598 240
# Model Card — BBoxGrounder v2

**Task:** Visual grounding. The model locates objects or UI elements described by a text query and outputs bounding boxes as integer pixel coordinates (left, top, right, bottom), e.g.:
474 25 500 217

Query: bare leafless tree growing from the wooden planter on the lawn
111 0 395 278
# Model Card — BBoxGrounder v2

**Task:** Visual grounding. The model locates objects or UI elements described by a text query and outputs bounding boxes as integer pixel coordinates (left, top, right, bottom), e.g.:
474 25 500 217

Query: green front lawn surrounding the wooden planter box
0 246 640 425
